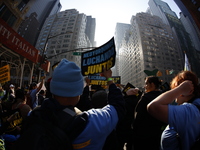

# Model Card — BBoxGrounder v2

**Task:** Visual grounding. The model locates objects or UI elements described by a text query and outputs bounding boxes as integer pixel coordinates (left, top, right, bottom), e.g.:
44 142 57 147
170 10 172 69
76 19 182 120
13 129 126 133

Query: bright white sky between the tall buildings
60 0 180 46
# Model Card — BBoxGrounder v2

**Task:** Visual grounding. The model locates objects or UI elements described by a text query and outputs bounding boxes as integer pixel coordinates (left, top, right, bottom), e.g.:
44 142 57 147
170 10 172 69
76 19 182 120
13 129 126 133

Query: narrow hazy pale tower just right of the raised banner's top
112 23 130 76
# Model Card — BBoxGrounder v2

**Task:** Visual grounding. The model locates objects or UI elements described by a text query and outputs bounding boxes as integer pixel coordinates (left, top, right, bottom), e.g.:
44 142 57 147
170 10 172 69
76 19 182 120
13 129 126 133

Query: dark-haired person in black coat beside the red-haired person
133 76 167 150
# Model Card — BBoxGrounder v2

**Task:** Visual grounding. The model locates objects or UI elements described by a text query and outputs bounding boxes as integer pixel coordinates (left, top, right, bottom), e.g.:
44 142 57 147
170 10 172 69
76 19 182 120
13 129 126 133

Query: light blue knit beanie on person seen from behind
50 59 84 97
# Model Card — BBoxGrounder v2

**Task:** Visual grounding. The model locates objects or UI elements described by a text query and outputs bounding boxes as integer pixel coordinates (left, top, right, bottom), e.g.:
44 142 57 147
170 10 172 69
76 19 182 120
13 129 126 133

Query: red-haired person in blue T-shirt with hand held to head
147 71 200 150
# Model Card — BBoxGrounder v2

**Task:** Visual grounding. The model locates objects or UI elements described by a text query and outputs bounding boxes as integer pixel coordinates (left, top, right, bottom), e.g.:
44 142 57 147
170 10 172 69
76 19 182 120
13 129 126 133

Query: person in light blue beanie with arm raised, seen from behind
18 59 125 150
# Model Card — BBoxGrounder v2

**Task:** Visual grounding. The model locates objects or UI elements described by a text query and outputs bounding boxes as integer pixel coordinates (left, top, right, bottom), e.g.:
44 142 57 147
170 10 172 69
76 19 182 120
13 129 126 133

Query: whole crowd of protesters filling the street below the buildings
0 59 200 150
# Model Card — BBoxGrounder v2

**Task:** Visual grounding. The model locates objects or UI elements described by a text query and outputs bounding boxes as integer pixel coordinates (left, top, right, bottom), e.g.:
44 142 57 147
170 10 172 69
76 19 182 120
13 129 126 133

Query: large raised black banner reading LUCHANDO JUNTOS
81 37 116 76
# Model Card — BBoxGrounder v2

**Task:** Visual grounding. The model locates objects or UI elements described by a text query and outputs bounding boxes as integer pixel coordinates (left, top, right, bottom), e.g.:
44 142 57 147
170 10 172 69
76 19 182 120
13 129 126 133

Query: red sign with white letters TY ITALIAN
0 18 39 63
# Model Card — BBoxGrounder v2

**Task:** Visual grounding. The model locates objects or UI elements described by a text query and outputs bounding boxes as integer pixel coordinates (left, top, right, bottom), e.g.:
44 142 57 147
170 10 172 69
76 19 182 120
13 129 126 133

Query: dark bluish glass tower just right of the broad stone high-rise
148 0 200 77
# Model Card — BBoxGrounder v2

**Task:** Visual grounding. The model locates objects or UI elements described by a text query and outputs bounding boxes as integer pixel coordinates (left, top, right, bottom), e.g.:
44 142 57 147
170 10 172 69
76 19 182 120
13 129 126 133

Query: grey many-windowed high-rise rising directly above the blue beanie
36 9 93 75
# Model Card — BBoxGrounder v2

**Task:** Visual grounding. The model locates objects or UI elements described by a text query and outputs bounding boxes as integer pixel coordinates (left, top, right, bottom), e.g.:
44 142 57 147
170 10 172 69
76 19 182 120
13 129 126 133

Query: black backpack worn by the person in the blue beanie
13 107 87 150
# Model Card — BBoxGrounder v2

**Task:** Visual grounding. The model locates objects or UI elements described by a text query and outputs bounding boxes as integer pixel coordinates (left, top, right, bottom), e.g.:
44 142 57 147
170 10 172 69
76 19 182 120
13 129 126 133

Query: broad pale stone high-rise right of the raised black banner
119 13 183 88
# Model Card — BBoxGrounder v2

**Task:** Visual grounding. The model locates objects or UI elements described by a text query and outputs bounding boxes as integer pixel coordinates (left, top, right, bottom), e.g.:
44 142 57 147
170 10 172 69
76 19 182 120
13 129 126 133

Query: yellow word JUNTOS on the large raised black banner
84 57 113 75
